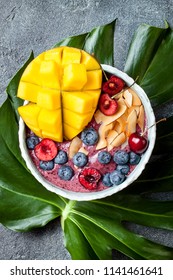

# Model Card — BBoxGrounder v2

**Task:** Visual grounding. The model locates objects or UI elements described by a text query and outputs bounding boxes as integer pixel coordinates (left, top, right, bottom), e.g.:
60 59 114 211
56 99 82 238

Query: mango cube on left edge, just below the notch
18 103 41 128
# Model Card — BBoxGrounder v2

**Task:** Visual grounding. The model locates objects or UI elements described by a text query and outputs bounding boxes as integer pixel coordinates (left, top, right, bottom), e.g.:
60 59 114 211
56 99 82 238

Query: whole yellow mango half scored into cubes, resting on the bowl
17 46 102 142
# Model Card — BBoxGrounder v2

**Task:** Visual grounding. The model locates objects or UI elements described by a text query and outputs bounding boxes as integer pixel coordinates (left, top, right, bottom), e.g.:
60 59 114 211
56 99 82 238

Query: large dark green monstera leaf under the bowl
0 21 173 260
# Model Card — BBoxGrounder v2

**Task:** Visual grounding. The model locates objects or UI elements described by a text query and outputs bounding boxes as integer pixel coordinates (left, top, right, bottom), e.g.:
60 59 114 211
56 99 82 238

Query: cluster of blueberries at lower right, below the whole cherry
102 150 141 187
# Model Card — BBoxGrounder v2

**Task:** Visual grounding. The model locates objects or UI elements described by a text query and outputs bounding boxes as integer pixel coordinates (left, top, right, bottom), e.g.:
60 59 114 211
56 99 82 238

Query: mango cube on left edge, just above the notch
17 81 40 103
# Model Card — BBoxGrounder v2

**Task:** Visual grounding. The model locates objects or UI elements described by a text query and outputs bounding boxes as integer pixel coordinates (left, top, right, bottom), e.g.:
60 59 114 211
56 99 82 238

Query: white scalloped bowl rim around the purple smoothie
19 64 156 201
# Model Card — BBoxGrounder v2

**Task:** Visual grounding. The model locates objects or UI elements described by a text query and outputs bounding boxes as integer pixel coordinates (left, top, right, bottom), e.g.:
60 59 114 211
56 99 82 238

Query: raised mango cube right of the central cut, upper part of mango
62 63 87 90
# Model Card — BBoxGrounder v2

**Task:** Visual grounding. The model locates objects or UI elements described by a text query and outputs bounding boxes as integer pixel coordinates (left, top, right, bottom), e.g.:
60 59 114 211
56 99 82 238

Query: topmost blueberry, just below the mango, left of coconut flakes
81 127 99 146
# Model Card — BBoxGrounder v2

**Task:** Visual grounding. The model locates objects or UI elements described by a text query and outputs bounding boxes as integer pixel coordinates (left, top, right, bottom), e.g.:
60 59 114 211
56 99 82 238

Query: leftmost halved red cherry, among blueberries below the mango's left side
34 138 58 161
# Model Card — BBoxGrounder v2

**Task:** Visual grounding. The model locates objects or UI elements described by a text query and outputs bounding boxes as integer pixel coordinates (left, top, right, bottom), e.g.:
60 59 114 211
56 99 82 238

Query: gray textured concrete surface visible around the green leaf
0 0 173 260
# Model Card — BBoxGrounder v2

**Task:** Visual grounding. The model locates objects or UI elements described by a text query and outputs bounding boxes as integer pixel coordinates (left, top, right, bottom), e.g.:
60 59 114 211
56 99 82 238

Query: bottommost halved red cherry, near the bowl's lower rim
79 168 101 190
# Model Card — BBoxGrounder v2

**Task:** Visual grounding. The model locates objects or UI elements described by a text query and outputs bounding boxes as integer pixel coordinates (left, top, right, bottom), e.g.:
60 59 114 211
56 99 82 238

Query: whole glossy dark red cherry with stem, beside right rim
128 132 148 154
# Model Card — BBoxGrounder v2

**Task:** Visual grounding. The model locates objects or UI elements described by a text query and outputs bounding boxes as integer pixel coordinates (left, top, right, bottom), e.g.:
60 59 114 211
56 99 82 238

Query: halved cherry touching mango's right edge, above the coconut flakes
98 93 118 116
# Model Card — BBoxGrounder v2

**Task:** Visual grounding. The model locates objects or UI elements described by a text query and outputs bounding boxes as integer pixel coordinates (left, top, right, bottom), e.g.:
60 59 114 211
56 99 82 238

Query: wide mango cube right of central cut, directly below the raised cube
62 91 95 114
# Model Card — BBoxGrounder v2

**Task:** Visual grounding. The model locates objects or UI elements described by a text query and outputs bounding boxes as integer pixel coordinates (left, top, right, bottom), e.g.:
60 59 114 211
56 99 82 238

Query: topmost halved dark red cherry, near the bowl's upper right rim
102 75 125 96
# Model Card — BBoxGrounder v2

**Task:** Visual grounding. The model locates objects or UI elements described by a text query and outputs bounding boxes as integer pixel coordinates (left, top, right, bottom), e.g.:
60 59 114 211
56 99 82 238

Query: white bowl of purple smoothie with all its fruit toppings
18 47 156 201
